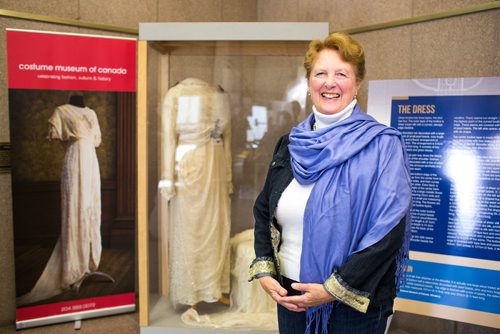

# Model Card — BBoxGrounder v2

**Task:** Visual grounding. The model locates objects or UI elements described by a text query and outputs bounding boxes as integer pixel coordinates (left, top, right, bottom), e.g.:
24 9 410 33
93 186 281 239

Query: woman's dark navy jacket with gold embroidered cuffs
250 135 405 312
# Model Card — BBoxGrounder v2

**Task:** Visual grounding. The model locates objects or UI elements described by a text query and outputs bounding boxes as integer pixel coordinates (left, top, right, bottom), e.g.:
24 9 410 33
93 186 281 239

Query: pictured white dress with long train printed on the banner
17 96 112 306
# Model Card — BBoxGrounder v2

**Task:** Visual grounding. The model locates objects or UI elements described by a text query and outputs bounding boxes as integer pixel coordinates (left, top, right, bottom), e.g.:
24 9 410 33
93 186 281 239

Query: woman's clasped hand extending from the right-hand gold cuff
280 283 335 309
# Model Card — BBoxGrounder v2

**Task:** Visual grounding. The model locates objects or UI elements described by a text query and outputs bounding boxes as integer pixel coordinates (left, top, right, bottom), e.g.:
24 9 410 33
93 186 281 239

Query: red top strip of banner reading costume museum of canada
7 30 136 92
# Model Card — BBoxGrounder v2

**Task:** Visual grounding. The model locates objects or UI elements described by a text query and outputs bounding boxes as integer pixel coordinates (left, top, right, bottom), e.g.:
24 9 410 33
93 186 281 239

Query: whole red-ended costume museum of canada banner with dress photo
6 29 136 329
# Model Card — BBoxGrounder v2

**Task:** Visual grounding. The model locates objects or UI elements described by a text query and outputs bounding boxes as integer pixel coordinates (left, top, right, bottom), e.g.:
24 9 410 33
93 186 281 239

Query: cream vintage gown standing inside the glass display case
159 78 232 307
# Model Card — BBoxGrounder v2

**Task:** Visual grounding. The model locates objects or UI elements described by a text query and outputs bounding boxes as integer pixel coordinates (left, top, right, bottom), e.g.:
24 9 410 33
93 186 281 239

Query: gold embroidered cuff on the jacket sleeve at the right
323 273 370 313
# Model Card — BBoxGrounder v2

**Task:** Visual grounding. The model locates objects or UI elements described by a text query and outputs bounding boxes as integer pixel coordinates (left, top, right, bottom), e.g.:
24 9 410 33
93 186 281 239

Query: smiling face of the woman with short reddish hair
308 49 360 115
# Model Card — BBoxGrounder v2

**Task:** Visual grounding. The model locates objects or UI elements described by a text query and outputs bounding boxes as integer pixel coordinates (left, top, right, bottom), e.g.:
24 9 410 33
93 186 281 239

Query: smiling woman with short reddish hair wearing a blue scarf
250 33 411 334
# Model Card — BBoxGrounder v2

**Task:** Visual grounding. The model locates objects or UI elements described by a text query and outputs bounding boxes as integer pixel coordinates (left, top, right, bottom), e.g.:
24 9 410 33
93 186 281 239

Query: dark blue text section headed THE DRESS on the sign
391 95 500 262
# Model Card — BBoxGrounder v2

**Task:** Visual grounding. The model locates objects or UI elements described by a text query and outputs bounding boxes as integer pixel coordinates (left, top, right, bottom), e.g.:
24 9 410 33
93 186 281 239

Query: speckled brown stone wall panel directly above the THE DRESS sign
411 11 500 78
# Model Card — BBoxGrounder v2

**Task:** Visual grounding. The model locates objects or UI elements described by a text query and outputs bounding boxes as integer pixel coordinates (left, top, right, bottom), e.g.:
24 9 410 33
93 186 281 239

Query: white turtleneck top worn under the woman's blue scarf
276 100 357 283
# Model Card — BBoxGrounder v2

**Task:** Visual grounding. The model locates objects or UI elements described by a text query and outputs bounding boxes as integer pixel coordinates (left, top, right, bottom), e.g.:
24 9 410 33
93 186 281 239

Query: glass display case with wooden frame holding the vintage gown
137 22 328 333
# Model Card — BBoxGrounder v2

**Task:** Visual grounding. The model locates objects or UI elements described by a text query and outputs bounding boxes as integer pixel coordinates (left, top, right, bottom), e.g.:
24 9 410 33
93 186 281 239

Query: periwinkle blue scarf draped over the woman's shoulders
288 105 411 333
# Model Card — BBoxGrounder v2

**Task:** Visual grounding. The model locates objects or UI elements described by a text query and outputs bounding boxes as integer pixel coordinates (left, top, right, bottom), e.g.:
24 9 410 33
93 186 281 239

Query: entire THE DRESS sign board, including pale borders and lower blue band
368 77 500 329
